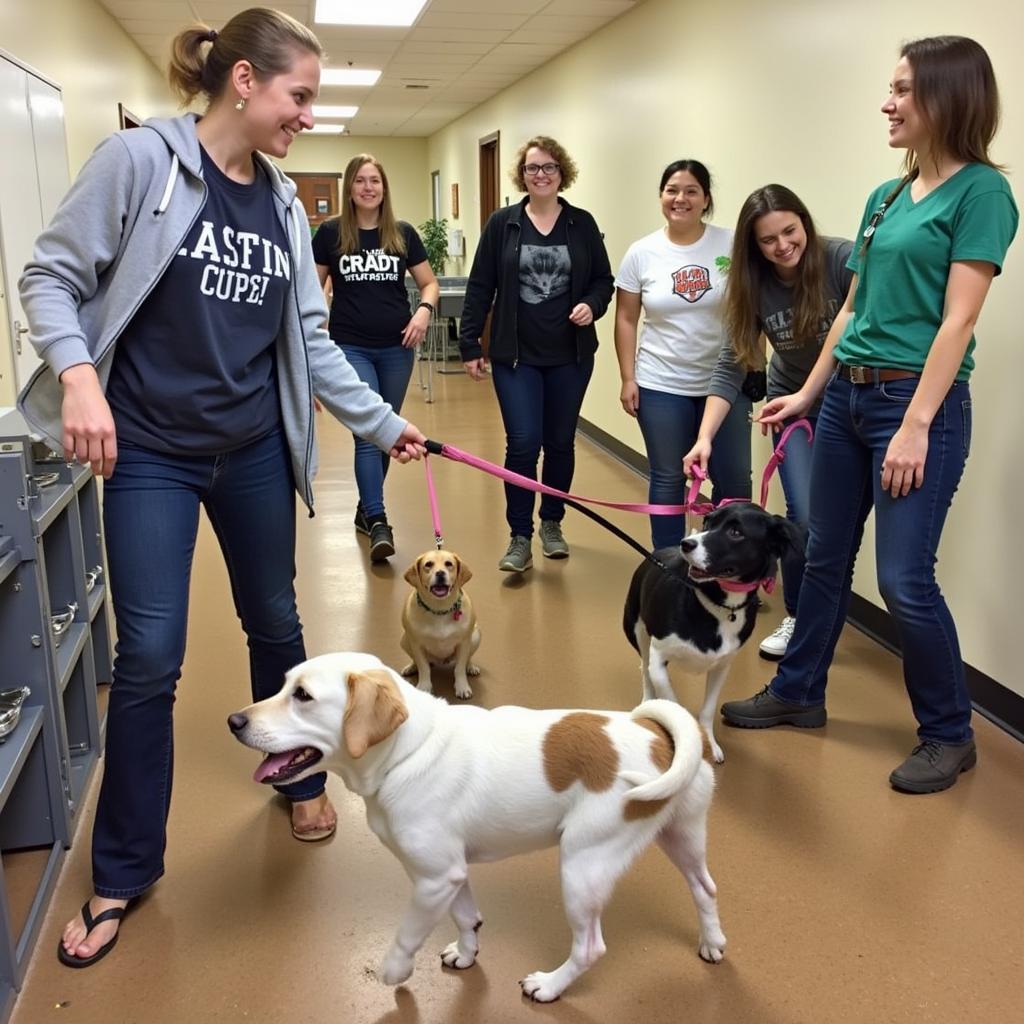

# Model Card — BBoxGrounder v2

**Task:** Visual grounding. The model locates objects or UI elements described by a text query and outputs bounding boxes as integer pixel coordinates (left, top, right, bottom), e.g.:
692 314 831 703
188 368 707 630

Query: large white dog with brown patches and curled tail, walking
227 653 725 1002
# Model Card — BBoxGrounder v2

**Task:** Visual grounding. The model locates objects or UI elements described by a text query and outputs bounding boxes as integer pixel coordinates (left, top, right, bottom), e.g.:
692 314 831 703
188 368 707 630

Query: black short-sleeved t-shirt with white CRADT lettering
313 218 427 348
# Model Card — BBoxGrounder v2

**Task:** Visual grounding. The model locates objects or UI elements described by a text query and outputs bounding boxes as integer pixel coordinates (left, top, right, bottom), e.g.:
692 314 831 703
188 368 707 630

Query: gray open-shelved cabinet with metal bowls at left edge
0 411 113 1021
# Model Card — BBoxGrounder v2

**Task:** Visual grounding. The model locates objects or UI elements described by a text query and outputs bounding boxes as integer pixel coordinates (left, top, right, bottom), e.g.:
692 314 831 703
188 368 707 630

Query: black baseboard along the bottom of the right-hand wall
580 417 1024 742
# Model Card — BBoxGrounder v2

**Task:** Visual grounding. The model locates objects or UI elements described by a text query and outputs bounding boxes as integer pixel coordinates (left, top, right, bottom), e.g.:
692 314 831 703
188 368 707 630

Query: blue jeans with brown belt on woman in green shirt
770 378 973 743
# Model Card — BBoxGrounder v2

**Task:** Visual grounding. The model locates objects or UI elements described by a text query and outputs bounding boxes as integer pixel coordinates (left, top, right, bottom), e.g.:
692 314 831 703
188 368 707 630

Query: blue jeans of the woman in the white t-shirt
637 387 751 551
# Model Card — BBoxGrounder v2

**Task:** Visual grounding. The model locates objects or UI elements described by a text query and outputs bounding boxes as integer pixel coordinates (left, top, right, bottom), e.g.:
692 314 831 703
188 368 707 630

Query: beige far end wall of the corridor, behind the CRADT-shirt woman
278 135 430 226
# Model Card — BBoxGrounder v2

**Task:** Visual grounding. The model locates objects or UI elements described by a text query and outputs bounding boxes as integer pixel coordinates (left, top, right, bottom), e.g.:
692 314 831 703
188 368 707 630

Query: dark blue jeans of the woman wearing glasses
490 355 594 537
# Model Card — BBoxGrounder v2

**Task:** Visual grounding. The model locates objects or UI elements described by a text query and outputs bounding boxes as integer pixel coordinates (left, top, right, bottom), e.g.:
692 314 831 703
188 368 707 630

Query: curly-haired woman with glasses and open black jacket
460 135 612 572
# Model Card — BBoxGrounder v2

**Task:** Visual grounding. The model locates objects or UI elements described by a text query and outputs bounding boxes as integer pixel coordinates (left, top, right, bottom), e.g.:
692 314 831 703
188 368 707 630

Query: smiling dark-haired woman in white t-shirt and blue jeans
615 160 751 549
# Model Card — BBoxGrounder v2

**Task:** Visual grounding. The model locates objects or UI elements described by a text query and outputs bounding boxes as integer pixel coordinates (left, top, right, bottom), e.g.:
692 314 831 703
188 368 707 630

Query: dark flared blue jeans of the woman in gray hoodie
92 432 326 899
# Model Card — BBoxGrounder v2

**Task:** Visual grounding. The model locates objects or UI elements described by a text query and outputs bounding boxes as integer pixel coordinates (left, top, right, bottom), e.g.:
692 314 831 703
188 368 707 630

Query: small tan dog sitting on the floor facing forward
401 551 480 700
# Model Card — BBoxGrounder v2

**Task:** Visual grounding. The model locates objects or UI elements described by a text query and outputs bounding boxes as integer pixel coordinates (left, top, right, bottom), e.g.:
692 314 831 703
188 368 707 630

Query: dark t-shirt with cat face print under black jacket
517 211 577 367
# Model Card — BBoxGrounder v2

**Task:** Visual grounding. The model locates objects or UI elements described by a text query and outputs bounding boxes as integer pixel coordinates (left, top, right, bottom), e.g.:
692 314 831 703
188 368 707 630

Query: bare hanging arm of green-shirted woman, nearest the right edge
882 260 995 498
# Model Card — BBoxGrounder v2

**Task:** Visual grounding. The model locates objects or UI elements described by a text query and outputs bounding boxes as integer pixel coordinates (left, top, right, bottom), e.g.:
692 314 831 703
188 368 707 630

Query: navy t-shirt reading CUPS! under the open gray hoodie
106 150 292 455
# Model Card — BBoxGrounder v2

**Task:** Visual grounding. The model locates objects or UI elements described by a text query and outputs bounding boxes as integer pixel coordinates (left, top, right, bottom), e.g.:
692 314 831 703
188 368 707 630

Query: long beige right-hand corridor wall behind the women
427 0 1024 693
